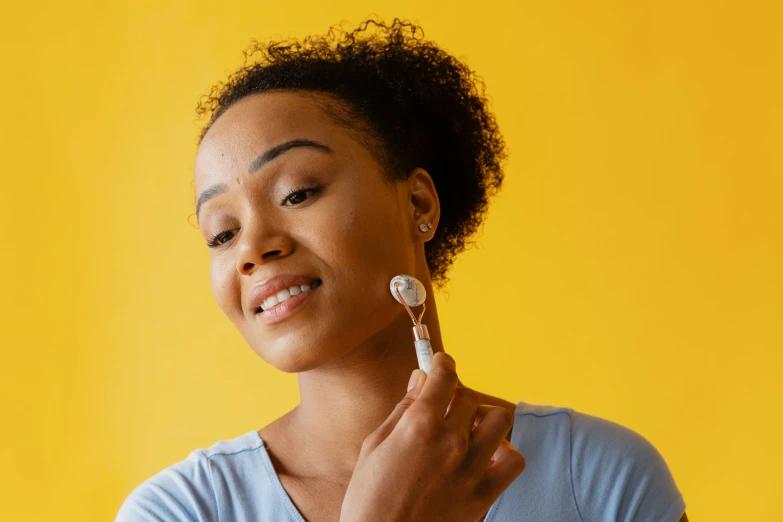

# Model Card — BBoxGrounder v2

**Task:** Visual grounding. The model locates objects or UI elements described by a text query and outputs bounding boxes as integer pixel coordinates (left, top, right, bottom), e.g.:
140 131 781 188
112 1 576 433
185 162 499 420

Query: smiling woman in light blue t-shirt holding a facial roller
117 19 687 522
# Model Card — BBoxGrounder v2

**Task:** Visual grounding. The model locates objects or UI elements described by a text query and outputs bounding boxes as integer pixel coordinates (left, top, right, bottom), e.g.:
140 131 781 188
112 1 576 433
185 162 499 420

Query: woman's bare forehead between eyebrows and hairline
194 91 355 193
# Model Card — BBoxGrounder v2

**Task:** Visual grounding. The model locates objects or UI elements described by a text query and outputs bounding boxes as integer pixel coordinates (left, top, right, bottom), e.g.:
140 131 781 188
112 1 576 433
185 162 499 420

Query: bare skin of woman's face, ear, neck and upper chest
195 91 688 521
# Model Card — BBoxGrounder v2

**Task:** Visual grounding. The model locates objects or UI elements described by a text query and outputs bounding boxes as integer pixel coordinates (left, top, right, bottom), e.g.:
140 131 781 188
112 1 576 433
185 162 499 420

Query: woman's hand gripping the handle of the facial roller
340 352 525 522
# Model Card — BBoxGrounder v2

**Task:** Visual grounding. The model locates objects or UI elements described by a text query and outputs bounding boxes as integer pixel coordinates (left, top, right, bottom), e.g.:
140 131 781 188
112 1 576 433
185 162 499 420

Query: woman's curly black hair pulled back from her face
196 18 506 288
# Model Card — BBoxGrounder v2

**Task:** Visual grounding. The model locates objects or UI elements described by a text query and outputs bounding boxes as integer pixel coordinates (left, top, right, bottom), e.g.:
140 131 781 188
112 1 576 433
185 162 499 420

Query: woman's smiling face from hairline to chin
195 91 435 372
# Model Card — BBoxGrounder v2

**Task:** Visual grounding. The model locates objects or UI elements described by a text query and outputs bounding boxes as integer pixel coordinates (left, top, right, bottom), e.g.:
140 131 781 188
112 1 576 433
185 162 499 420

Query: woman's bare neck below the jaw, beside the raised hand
289 285 443 478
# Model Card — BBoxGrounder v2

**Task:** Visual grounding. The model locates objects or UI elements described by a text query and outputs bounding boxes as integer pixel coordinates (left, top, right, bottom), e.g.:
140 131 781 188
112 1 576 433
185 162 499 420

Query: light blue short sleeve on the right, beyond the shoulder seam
569 409 685 522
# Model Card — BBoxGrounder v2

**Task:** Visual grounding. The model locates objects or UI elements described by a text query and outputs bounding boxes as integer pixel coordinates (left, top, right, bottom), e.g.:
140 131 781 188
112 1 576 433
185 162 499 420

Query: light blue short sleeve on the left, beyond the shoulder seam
115 450 218 522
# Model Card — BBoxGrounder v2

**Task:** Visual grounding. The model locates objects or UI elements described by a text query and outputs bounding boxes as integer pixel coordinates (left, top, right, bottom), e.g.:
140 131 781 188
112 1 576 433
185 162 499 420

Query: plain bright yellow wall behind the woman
0 0 783 522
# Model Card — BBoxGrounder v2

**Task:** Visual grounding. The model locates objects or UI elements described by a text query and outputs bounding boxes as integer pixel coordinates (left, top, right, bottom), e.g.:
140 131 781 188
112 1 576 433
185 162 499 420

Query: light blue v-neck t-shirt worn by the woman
115 401 685 522
